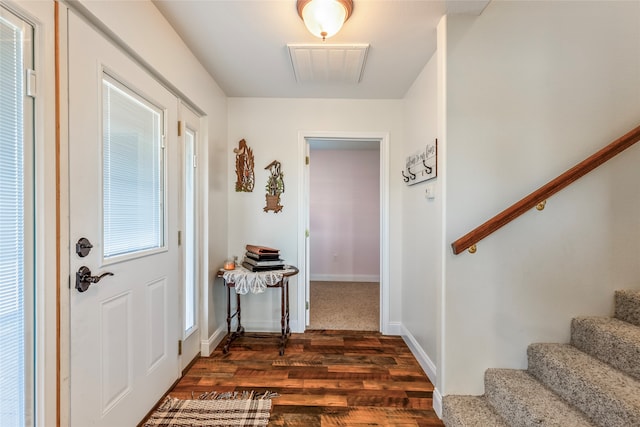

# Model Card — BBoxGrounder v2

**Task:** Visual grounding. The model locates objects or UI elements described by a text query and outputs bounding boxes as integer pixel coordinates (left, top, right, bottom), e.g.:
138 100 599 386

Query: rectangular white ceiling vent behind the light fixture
287 43 369 84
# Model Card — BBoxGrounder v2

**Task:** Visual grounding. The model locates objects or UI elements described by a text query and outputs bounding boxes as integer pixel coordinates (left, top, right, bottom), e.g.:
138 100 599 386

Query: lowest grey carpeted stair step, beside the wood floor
442 396 509 427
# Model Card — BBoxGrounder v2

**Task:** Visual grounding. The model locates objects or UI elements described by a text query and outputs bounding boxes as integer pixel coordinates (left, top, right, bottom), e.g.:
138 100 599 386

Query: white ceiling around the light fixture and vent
153 0 489 99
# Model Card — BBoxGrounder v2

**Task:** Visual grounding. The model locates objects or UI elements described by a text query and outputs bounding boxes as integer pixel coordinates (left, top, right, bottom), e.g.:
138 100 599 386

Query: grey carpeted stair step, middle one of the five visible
527 344 640 427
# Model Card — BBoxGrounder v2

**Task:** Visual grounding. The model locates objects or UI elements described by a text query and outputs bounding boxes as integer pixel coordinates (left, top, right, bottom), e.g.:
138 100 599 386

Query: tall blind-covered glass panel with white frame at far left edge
0 4 34 427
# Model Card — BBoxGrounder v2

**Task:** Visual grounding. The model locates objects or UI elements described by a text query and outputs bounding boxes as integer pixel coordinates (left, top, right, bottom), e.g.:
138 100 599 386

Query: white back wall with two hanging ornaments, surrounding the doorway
228 98 402 330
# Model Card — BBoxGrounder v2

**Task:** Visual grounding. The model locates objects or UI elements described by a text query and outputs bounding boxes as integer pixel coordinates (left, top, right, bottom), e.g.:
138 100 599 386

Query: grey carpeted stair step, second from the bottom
485 369 596 427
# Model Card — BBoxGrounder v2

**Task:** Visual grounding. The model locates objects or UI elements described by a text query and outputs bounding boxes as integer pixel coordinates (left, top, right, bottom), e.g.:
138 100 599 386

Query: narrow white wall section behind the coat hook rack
400 51 443 384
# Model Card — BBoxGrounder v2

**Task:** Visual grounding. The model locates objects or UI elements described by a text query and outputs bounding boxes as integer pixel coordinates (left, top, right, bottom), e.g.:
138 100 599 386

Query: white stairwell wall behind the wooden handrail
440 1 640 394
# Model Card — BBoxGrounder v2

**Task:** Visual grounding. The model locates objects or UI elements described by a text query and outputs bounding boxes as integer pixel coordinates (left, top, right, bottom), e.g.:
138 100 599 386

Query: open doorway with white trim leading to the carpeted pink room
298 133 389 333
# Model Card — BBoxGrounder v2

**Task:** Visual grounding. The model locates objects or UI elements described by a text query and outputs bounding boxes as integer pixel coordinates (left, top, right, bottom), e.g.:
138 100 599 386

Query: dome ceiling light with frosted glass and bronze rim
297 0 353 41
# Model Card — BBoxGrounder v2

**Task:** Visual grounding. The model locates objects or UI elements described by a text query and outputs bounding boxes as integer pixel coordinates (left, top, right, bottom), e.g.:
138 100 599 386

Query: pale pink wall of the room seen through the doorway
309 149 380 281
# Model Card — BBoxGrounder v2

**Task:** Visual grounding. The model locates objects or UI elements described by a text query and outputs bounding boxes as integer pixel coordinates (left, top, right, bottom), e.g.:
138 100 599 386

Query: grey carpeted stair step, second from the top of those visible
571 317 640 380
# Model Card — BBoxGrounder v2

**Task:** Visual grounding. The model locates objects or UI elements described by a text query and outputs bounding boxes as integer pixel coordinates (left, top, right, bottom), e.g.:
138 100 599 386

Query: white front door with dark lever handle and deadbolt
68 13 182 427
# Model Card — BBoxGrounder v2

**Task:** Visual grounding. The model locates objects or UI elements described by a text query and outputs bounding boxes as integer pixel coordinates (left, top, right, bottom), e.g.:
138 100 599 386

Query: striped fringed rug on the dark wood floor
144 392 277 427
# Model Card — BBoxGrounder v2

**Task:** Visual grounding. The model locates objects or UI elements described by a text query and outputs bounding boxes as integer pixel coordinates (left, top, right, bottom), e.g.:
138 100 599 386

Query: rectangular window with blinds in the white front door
102 74 166 262
